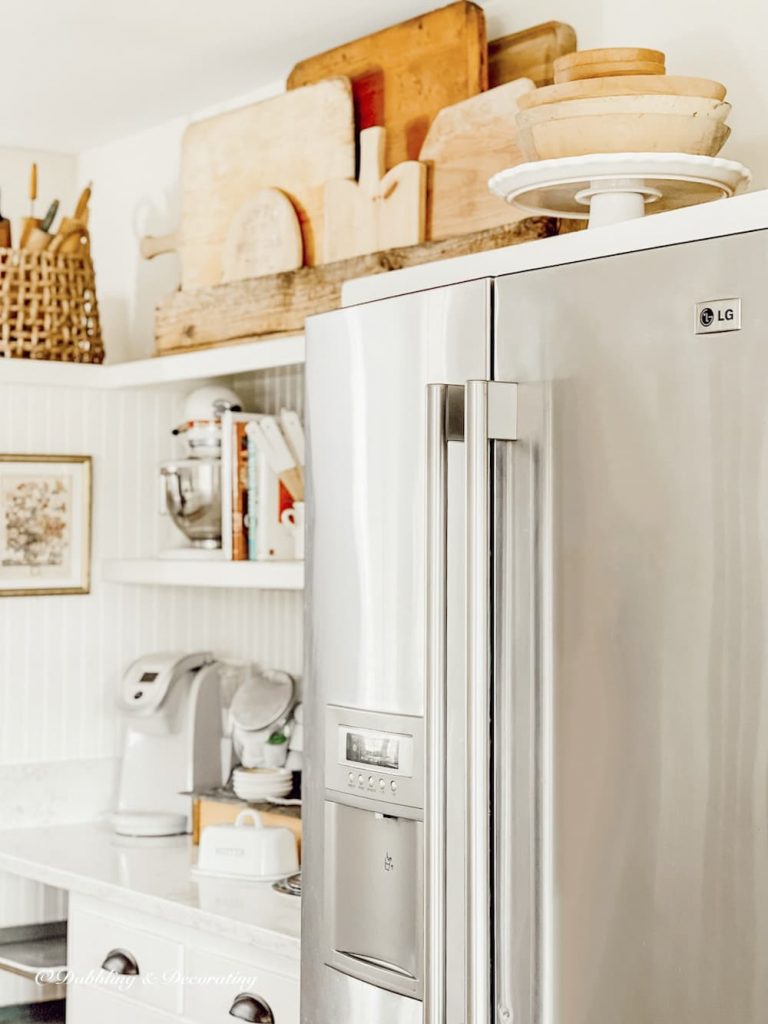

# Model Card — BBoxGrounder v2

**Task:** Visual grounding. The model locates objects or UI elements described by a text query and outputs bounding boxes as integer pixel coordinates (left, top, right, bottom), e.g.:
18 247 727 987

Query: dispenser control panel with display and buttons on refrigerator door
326 706 424 808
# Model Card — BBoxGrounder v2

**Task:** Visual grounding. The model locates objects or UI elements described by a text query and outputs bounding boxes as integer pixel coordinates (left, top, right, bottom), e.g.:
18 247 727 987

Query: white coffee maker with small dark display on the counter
112 651 223 836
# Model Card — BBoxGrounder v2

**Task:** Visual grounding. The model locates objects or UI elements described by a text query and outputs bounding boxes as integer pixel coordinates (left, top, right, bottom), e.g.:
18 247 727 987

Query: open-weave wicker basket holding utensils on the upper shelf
0 248 104 362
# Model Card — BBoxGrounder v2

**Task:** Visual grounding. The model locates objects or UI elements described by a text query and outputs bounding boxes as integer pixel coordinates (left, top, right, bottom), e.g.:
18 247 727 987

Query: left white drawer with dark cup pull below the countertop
68 910 183 1024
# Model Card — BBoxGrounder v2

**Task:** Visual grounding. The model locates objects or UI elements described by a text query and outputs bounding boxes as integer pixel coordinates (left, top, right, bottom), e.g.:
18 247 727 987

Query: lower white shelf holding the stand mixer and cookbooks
101 558 304 590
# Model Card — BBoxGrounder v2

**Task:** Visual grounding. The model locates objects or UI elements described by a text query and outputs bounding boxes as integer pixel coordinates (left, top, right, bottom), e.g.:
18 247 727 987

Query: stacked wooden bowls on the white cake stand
517 48 731 160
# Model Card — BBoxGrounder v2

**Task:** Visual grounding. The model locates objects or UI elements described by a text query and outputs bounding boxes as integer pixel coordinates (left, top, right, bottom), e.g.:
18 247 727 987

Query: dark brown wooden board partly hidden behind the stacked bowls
488 22 577 89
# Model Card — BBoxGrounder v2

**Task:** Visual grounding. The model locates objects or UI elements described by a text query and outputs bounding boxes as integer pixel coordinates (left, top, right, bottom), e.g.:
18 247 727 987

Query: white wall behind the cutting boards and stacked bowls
79 0 768 359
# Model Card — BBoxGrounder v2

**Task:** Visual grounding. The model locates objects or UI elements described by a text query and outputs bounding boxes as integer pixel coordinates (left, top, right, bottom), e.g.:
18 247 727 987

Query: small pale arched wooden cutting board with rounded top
221 188 304 283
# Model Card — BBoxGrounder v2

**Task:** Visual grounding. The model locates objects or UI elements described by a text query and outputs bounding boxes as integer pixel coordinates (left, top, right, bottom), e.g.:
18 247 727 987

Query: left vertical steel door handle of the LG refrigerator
424 384 464 1024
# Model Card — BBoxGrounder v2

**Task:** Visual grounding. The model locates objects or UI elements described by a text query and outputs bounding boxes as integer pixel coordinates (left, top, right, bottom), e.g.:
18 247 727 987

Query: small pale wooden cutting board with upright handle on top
325 128 427 263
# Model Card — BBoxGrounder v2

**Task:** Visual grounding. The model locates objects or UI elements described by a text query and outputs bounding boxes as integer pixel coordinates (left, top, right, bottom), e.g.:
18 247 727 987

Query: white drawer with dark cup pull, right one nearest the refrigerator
184 949 299 1024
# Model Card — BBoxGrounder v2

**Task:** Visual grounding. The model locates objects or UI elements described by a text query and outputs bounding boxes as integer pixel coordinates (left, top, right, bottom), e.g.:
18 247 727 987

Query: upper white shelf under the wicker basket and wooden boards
0 334 304 390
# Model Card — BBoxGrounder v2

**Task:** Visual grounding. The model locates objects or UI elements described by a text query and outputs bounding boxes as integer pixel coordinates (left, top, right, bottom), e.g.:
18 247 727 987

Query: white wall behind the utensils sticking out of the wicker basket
0 147 78 248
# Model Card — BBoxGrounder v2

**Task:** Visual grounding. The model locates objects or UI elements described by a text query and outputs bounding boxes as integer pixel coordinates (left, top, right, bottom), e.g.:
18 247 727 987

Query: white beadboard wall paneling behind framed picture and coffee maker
0 369 303 765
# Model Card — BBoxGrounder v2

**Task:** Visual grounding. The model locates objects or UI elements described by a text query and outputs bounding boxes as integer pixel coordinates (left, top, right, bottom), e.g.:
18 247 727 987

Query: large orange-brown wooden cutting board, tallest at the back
288 2 487 168
